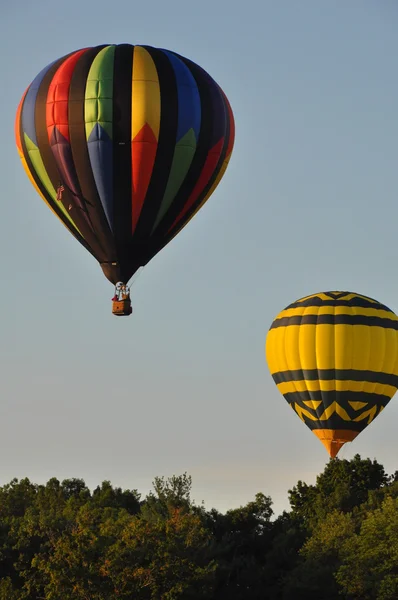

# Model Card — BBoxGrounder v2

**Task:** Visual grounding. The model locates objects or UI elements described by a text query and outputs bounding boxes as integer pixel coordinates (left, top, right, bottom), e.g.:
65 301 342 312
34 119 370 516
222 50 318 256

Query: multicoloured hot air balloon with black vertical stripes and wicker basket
15 44 234 315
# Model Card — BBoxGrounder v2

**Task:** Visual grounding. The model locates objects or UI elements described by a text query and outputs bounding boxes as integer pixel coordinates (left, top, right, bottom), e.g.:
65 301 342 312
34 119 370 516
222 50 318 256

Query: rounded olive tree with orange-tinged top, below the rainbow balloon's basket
103 508 215 600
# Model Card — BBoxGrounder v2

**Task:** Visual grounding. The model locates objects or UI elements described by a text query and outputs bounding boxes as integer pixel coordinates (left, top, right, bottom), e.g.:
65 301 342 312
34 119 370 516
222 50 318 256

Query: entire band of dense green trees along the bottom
0 455 398 600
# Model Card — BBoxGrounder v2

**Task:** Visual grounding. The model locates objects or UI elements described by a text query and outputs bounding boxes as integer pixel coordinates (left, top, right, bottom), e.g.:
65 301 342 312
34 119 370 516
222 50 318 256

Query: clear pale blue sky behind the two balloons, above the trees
0 0 398 512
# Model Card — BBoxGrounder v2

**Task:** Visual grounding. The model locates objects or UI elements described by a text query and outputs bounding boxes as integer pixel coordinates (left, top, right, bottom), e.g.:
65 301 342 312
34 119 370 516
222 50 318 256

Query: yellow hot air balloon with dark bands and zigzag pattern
265 292 398 458
